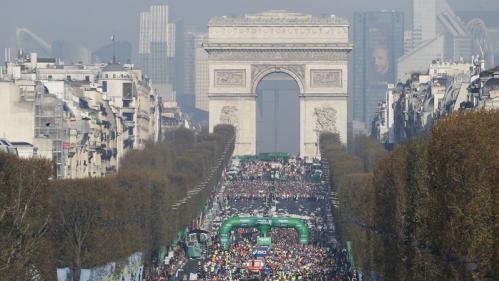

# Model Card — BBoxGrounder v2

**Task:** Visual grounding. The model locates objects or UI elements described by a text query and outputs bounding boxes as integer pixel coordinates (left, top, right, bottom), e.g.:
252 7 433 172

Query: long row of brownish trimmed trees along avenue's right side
321 111 499 281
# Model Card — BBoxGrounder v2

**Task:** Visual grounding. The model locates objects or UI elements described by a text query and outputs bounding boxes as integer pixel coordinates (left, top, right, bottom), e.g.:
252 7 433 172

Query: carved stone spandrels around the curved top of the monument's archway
251 64 305 94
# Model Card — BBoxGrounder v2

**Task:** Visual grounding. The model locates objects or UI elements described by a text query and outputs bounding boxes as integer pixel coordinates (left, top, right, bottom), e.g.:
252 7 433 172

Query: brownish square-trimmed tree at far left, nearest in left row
0 153 51 280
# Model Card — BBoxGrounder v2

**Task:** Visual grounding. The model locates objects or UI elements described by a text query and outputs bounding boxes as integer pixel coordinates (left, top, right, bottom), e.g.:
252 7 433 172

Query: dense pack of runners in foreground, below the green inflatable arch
198 230 352 280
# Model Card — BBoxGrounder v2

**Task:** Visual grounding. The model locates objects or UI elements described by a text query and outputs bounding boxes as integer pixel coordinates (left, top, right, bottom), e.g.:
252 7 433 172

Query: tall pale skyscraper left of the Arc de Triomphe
139 6 176 101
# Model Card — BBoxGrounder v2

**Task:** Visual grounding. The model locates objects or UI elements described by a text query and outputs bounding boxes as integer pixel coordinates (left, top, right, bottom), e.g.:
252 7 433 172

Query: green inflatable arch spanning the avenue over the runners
219 217 310 250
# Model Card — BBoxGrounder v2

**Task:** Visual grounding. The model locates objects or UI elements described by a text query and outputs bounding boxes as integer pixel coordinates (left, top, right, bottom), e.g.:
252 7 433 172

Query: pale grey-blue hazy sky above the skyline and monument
0 0 499 57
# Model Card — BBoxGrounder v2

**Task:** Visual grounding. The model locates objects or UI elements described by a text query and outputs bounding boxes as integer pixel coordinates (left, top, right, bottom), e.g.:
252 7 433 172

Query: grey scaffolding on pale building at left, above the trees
35 85 66 179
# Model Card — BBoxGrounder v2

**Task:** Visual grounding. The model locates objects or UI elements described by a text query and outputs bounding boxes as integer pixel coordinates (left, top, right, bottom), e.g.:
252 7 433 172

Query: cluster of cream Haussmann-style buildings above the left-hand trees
0 54 161 178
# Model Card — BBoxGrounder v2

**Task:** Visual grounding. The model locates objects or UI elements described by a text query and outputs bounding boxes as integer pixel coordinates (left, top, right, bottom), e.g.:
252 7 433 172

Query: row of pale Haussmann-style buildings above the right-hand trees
372 59 499 143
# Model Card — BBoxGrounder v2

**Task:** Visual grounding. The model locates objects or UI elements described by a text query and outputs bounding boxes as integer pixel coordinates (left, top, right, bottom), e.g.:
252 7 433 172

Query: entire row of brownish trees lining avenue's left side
0 125 234 280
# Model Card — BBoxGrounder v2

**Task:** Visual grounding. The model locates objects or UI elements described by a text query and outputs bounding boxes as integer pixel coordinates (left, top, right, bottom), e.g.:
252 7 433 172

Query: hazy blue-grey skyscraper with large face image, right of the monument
350 11 404 133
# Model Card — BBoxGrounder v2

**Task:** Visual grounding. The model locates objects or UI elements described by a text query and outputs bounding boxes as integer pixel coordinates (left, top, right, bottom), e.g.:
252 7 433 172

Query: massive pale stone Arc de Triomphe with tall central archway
203 11 352 156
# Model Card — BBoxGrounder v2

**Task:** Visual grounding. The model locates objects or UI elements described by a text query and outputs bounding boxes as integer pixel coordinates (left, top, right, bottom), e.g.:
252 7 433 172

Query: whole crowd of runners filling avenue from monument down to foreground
141 159 360 281
